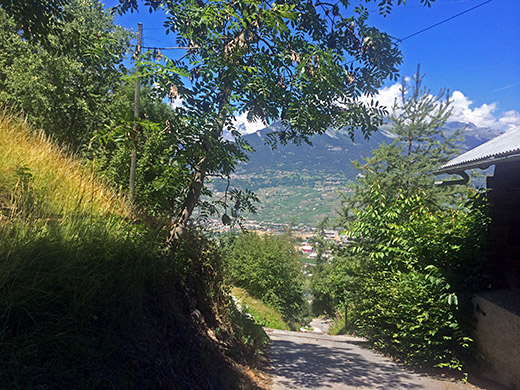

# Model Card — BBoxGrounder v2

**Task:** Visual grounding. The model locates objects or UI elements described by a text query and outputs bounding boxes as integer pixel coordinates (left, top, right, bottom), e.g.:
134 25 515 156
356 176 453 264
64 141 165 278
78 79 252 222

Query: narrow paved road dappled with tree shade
267 329 486 390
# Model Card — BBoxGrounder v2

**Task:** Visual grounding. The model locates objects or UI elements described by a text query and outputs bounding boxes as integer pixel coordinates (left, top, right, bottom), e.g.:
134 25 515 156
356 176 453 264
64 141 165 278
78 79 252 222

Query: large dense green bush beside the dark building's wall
328 186 488 369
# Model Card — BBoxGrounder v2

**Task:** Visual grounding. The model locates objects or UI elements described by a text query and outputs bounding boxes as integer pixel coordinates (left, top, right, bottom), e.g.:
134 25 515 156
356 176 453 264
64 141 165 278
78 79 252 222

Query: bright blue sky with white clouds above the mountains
106 0 520 131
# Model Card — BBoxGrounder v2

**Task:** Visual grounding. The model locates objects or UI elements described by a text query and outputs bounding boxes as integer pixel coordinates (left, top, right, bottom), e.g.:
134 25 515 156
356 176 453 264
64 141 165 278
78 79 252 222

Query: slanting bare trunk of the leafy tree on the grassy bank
166 156 208 247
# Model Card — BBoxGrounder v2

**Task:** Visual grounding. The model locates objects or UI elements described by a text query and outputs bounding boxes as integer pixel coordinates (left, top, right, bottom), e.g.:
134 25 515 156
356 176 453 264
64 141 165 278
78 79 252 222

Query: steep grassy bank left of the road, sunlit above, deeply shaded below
0 112 266 389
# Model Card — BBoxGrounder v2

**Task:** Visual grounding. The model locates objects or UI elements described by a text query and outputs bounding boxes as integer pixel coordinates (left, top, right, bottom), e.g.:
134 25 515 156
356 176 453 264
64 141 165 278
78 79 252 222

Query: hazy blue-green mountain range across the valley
212 122 501 226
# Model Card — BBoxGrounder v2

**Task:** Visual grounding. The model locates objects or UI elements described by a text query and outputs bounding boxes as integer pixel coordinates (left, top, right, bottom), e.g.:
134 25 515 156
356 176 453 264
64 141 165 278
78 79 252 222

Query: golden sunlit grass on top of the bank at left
0 111 131 218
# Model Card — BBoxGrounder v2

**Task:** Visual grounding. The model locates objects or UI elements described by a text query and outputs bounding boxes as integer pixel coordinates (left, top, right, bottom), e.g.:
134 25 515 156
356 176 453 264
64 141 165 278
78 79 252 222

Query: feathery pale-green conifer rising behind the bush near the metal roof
343 65 461 219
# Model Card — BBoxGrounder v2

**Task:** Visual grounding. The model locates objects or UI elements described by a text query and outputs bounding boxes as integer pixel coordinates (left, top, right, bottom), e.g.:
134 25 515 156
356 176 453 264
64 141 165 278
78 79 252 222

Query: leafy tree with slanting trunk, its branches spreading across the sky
112 0 429 242
